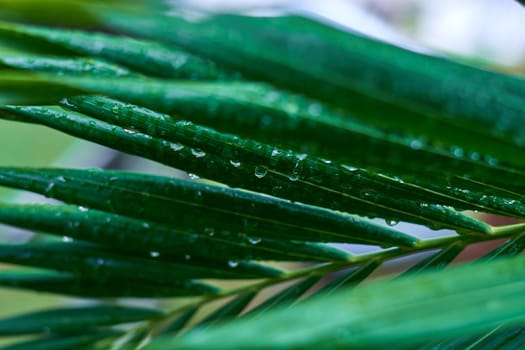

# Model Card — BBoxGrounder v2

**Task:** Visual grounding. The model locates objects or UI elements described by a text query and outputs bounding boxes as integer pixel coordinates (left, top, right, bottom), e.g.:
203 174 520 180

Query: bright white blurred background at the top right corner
170 0 525 66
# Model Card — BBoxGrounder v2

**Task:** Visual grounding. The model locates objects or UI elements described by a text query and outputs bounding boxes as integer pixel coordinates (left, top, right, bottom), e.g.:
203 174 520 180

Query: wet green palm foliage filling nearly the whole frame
0 0 525 350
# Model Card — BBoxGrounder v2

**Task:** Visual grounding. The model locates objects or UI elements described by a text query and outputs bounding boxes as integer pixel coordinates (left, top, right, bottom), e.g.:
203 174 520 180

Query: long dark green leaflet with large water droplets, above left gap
2 106 491 233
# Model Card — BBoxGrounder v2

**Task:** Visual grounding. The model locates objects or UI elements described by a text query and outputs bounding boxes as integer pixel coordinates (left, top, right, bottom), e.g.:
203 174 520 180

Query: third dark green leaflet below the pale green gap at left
0 243 283 280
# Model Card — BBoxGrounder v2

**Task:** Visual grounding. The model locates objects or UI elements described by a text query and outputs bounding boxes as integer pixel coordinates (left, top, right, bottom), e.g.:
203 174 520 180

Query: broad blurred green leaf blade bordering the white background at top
101 14 525 152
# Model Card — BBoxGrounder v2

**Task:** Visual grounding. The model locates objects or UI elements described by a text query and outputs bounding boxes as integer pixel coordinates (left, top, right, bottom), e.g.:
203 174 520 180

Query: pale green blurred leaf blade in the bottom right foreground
146 257 524 349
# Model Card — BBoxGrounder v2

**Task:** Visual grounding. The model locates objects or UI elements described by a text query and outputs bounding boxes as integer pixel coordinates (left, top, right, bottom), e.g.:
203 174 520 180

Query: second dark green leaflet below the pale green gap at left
0 201 350 261
